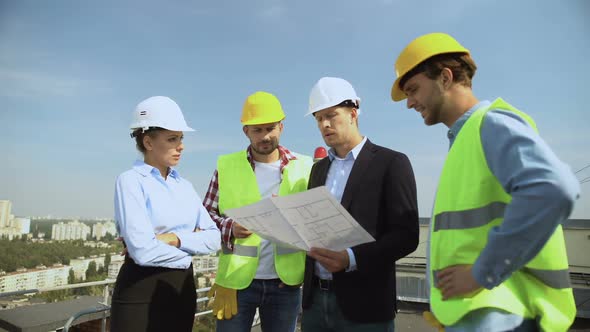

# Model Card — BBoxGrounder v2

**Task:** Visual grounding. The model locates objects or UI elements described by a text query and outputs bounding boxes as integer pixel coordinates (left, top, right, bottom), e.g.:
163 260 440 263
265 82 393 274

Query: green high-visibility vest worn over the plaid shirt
215 151 313 289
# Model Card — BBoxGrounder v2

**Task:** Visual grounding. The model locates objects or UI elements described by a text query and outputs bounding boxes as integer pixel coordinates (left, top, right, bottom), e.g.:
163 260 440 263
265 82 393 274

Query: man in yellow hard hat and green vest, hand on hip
391 33 580 331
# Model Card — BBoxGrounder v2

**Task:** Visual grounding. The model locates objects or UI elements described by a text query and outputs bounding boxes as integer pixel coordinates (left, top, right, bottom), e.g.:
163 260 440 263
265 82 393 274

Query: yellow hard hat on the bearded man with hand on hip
391 32 469 101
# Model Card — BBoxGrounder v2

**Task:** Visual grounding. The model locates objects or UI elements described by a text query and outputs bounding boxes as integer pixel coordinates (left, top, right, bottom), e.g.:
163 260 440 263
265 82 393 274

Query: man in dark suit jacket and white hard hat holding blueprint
302 77 418 332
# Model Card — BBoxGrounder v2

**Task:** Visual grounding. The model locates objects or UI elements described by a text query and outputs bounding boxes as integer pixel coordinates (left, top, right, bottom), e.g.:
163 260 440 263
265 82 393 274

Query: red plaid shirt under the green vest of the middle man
203 145 297 250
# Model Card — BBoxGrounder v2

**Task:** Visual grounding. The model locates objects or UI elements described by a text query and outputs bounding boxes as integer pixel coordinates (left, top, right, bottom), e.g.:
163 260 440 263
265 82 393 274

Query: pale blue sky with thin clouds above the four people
0 0 590 218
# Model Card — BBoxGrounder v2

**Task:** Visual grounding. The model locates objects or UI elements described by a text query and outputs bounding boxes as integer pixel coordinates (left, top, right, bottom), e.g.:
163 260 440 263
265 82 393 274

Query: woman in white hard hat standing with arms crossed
111 96 221 332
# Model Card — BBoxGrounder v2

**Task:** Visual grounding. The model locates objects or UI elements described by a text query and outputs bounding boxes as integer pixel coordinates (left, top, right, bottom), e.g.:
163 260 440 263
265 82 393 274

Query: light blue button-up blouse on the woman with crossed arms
115 160 221 269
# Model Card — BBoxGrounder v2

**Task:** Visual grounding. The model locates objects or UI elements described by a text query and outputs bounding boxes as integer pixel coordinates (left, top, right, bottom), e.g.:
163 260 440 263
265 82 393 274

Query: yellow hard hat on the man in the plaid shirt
240 91 285 126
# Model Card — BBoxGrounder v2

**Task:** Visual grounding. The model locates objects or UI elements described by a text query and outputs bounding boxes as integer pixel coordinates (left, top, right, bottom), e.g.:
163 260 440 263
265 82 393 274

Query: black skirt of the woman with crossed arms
111 258 197 332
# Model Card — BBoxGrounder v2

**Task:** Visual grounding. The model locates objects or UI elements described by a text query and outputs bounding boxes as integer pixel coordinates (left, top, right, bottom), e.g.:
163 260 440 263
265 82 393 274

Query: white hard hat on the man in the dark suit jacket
305 77 361 116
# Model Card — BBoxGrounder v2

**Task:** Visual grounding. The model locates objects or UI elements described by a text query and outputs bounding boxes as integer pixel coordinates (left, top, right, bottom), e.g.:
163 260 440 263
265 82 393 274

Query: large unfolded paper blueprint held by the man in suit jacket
225 186 375 251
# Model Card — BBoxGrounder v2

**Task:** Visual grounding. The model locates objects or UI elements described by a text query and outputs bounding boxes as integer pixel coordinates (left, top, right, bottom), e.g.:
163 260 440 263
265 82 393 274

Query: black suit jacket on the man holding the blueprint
303 140 418 322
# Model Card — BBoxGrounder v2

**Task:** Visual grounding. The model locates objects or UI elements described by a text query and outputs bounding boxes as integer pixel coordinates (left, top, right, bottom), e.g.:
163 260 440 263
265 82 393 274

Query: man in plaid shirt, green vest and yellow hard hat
204 92 313 332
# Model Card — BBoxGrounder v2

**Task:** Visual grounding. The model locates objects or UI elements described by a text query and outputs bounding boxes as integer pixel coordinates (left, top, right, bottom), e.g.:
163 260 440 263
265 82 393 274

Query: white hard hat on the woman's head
129 96 195 131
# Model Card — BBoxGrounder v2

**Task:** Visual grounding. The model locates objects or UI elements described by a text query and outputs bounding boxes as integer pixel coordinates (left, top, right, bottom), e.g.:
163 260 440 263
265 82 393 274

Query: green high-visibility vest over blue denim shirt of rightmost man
429 98 576 331
